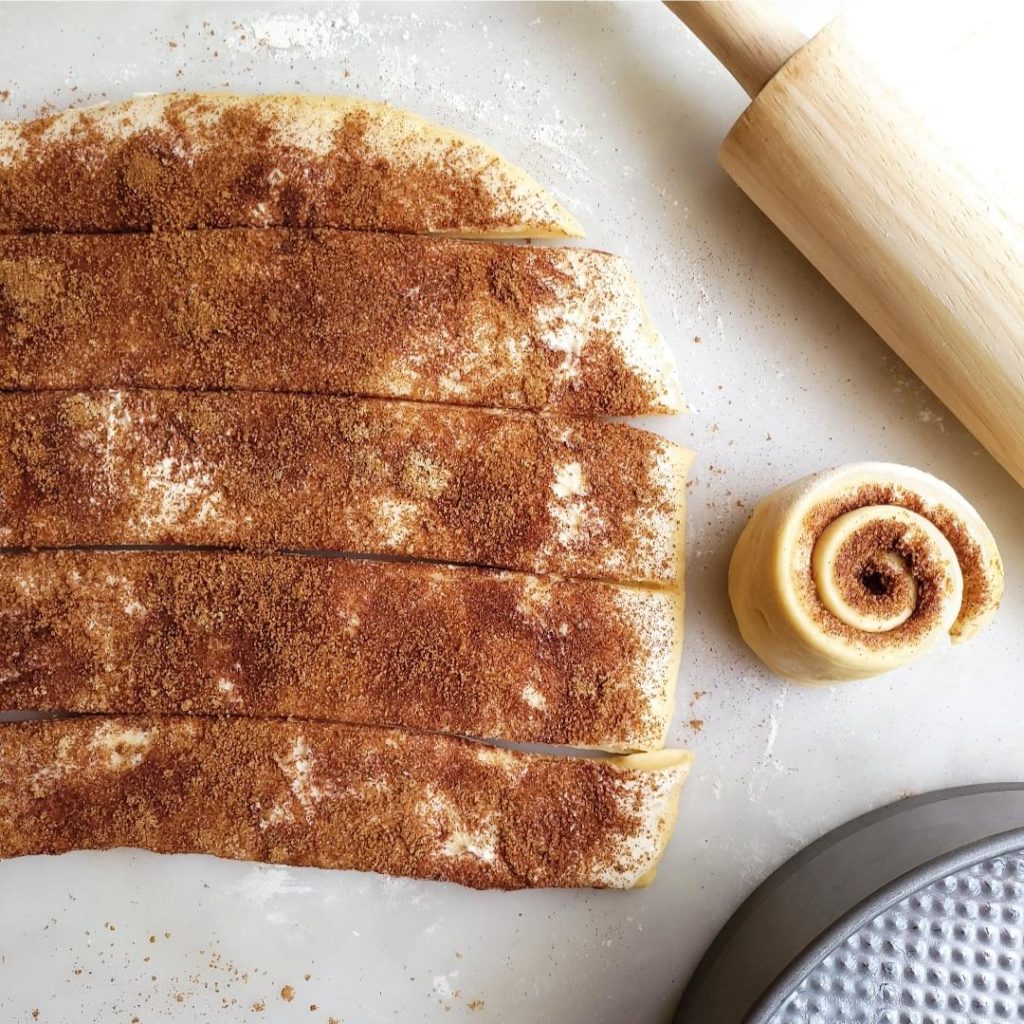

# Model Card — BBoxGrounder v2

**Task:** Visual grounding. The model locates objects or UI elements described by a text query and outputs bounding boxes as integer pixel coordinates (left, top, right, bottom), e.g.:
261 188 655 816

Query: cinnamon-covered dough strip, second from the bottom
0 551 682 751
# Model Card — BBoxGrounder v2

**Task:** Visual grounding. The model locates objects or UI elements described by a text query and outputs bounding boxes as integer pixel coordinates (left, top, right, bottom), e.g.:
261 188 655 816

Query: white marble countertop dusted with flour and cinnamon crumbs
0 0 1024 1024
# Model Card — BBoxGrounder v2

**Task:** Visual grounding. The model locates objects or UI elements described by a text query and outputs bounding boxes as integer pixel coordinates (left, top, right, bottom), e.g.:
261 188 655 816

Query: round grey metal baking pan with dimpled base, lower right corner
675 783 1024 1024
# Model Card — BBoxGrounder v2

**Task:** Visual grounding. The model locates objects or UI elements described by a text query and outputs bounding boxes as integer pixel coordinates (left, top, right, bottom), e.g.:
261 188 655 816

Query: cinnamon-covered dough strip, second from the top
0 228 680 416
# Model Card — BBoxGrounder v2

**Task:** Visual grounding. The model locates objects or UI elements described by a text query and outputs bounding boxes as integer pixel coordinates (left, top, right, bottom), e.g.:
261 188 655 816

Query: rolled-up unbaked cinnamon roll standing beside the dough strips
729 462 1002 682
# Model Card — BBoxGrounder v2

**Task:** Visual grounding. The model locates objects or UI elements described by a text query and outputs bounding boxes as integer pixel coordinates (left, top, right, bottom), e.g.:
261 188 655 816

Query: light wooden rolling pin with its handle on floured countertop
667 2 1024 485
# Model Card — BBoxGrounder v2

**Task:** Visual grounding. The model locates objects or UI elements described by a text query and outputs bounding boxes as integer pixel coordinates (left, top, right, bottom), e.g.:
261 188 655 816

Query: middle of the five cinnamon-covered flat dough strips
0 391 689 586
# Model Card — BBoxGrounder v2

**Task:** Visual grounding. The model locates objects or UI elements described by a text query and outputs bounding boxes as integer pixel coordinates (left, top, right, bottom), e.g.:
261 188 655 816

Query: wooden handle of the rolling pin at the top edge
665 0 807 99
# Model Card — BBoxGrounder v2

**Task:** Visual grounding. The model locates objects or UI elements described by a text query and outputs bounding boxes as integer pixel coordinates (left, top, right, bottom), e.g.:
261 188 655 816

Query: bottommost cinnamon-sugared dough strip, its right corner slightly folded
0 718 690 889
